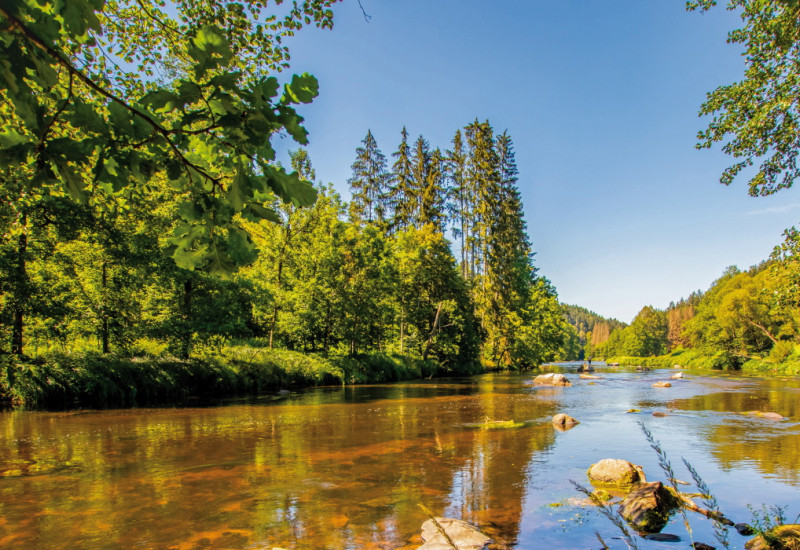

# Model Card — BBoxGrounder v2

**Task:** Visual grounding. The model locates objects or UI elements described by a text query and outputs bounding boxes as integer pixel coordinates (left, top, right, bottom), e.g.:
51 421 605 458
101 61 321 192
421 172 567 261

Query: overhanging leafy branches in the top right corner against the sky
686 0 800 196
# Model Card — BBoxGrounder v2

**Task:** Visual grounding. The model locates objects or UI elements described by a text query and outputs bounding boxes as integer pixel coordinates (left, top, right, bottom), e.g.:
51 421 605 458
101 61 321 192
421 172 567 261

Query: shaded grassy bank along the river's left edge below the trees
0 345 444 408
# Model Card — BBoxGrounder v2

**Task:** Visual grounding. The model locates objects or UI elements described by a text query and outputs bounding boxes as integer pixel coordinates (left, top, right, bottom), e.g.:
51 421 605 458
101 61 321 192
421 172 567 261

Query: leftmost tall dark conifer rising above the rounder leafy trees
348 130 388 223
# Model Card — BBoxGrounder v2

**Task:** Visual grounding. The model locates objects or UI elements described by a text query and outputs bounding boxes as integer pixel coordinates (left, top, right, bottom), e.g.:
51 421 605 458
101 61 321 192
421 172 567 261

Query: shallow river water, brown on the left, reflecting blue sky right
0 365 800 550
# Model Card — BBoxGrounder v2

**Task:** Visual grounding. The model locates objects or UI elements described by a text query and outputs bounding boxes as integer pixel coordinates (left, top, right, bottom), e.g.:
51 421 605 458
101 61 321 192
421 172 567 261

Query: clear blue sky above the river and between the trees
281 0 800 322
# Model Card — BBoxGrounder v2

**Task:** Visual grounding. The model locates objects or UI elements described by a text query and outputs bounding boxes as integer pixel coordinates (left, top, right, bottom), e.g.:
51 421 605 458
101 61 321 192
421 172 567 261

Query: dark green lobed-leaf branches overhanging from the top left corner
0 0 332 274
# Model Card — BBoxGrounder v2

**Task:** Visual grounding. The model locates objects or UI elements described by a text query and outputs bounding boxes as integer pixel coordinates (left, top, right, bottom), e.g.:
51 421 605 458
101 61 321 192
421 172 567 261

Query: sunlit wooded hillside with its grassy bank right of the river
567 228 800 374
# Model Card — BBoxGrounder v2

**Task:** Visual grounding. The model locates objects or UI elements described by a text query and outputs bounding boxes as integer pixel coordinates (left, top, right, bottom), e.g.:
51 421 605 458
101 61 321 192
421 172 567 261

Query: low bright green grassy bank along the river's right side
606 346 800 376
